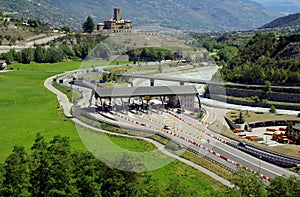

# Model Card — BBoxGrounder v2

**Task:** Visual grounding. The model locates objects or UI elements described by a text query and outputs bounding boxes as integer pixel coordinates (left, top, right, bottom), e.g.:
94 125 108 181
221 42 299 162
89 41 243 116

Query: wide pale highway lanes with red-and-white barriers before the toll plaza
110 107 295 178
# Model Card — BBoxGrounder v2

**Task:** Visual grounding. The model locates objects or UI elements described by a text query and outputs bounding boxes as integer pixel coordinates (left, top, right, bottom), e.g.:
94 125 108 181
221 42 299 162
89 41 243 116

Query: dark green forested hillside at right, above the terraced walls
221 32 300 83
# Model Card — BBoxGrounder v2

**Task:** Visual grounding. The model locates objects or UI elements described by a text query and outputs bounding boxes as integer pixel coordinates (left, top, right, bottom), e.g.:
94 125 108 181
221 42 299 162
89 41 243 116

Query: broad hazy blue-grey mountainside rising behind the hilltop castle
1 0 281 31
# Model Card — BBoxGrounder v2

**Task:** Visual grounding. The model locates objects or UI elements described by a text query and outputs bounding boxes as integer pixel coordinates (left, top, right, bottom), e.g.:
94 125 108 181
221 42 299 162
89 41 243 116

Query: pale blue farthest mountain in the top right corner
254 0 300 15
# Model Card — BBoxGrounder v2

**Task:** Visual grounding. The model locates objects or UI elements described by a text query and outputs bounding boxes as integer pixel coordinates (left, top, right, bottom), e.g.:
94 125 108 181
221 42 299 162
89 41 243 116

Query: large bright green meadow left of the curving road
0 62 84 161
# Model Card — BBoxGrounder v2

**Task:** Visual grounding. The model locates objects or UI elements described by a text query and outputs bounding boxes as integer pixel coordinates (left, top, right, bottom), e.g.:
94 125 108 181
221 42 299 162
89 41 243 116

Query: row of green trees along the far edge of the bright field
0 34 111 64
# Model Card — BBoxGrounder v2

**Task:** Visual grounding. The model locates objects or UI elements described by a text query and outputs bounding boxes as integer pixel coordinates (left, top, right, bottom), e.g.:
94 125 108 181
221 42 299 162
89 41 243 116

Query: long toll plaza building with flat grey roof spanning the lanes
95 86 201 112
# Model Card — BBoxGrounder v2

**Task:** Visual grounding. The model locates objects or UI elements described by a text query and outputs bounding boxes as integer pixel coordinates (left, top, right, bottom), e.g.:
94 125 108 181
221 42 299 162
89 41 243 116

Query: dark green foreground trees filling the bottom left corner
0 134 209 197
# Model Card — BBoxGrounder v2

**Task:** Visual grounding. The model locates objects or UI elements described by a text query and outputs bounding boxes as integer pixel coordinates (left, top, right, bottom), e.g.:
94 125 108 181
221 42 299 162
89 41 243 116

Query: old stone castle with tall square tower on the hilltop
97 8 132 32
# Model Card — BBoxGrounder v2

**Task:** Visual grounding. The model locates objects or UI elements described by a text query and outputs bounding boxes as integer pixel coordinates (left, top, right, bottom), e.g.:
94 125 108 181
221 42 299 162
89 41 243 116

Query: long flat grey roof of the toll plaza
96 85 198 98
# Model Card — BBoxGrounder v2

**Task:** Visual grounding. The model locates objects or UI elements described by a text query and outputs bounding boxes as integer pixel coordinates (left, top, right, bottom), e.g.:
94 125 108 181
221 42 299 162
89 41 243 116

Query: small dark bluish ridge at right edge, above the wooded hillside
261 13 300 29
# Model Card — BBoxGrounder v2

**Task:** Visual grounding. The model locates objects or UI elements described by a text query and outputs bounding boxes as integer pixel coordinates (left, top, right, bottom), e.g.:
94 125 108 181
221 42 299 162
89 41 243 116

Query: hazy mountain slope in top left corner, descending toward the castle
0 0 80 26
